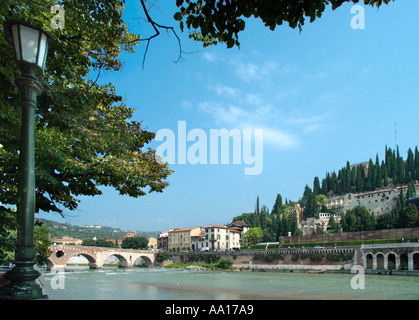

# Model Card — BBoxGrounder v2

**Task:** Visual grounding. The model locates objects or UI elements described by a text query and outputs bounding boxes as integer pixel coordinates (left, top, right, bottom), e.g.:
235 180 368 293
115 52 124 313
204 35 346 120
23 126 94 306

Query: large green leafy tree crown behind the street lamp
0 0 171 214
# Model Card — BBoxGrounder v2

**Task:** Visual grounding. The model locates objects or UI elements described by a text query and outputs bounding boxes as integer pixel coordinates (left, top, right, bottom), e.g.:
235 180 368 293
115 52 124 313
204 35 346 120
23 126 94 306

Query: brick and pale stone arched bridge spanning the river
47 245 156 270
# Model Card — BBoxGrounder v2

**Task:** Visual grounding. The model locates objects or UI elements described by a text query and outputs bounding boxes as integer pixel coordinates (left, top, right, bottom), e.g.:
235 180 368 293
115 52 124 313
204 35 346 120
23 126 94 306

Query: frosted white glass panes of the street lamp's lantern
12 24 48 70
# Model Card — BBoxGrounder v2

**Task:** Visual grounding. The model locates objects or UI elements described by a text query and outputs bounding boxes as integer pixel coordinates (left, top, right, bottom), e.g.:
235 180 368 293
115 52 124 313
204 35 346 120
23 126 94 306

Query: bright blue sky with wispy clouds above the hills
39 1 419 231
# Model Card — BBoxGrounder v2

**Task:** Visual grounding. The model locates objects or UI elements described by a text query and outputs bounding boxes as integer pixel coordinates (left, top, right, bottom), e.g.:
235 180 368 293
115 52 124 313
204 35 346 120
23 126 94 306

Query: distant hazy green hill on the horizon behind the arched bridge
36 219 160 240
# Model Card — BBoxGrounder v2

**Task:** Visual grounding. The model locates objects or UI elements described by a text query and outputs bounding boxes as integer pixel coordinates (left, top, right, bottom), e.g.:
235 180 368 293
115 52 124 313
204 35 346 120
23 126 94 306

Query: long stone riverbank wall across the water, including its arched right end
169 242 419 275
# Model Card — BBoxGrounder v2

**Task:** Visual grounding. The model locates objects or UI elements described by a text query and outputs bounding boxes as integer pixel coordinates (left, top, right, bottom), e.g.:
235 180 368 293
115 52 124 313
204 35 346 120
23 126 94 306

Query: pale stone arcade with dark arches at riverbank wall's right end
360 243 419 271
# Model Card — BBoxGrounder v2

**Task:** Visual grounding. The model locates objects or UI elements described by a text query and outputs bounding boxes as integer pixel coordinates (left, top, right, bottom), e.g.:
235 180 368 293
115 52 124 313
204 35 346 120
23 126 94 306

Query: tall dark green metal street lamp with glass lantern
0 21 54 299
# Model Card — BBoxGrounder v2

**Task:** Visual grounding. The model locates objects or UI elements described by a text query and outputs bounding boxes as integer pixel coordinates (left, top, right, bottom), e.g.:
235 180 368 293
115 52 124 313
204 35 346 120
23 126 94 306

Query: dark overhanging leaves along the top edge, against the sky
174 0 391 48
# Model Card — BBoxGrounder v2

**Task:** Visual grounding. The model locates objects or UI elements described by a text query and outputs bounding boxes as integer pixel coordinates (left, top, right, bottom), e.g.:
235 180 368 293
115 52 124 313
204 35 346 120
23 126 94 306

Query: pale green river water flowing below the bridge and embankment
39 268 419 300
